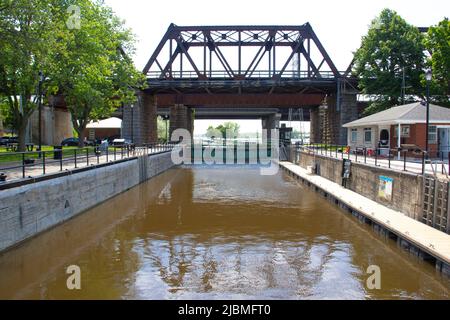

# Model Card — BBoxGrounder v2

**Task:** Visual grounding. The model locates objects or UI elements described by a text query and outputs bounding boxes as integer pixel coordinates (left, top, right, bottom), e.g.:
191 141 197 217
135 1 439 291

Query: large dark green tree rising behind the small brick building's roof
353 9 425 114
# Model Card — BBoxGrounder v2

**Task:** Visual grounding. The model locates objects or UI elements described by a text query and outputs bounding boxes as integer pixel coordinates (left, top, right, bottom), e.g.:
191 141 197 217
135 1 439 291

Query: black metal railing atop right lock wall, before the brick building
294 144 450 178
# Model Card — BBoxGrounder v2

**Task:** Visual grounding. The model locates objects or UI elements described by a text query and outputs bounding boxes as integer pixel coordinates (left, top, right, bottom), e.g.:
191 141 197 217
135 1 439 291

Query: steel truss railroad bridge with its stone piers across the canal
123 23 358 144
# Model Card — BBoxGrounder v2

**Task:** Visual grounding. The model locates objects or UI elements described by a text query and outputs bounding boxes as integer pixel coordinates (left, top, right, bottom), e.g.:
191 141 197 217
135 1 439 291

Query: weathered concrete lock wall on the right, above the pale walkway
297 152 423 220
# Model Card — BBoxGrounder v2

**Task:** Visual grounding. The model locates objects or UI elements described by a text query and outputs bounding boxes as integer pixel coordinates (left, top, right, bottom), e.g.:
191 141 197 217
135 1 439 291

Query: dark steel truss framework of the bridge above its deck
143 23 343 80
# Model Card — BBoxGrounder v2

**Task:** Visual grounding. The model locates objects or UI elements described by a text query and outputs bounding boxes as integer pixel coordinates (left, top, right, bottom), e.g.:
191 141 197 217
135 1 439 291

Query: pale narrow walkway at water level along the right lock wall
280 162 450 265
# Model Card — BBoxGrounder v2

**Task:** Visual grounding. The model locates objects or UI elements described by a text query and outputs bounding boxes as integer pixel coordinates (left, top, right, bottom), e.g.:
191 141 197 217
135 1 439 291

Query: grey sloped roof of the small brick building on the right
344 102 450 128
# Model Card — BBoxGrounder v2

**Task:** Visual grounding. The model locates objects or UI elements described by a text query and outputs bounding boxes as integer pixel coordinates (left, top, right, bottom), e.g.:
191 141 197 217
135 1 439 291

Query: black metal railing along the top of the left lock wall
0 144 174 184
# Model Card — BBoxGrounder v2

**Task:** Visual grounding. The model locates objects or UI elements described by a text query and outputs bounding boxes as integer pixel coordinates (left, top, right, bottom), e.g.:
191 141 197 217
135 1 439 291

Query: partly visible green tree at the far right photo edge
425 18 450 107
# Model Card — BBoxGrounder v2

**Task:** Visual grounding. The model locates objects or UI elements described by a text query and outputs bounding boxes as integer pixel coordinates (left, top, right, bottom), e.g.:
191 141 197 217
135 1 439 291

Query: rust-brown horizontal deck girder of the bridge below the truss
145 79 344 108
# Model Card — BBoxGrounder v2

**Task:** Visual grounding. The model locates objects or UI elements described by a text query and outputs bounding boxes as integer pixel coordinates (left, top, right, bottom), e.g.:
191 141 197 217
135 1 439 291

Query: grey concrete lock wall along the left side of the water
0 153 173 252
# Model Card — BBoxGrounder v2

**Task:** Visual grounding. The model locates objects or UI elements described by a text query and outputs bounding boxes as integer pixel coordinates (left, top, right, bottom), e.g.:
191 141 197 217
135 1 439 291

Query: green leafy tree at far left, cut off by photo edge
0 0 58 151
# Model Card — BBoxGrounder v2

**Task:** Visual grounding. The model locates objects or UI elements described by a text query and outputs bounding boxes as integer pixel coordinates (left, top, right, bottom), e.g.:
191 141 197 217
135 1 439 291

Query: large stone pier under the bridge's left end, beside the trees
122 92 158 145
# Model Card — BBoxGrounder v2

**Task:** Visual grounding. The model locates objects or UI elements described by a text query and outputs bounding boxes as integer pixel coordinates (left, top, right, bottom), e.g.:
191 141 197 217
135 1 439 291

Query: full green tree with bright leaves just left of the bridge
51 0 145 147
